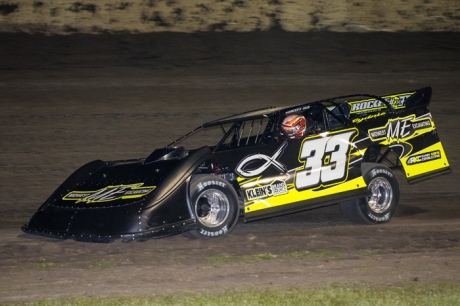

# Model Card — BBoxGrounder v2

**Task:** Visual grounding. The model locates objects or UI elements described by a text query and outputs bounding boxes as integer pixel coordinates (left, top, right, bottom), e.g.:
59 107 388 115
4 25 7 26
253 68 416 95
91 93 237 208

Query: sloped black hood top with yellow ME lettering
42 148 209 210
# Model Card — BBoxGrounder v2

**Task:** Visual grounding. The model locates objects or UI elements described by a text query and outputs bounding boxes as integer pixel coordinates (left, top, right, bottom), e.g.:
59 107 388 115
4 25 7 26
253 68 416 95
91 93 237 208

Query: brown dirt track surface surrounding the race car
0 32 460 302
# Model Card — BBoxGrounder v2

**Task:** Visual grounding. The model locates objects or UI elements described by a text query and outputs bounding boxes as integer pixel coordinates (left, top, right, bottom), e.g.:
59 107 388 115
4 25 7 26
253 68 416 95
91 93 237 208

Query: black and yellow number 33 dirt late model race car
22 87 451 242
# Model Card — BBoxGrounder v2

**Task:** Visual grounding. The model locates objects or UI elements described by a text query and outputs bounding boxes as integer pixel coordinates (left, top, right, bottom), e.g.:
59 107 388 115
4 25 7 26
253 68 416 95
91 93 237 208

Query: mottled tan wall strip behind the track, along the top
0 0 460 34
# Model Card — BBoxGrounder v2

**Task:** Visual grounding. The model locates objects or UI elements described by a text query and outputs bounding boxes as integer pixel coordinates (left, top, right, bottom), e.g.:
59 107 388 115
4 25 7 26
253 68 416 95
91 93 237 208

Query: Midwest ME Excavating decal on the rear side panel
368 115 434 157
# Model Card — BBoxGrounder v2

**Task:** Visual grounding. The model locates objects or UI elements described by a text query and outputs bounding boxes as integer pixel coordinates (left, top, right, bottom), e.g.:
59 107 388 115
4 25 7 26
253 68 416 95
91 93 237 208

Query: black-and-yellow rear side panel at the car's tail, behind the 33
351 87 451 183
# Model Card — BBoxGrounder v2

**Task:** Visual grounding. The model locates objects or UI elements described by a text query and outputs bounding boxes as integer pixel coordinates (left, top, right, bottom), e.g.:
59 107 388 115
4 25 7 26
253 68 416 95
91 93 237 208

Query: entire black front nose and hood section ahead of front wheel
23 147 210 242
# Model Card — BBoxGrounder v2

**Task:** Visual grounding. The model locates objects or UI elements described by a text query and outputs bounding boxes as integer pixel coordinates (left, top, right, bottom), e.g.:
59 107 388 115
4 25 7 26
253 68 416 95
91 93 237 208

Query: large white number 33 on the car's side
295 129 357 190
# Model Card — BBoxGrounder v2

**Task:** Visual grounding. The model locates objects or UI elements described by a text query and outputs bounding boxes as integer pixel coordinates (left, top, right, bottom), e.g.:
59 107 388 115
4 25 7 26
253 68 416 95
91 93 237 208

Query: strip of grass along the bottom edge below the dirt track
1 284 460 306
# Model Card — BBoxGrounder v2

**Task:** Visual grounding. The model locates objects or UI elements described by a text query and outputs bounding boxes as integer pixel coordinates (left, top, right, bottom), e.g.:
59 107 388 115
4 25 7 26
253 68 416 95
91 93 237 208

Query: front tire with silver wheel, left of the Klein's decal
182 175 240 239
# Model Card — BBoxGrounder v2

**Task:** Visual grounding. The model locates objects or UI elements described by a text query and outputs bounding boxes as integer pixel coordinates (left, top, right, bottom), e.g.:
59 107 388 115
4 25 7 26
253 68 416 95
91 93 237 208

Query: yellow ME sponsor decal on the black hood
62 183 156 204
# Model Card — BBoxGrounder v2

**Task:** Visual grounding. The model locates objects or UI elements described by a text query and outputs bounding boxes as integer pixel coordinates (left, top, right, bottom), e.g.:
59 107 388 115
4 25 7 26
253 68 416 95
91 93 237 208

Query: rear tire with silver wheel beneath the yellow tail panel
339 163 399 224
